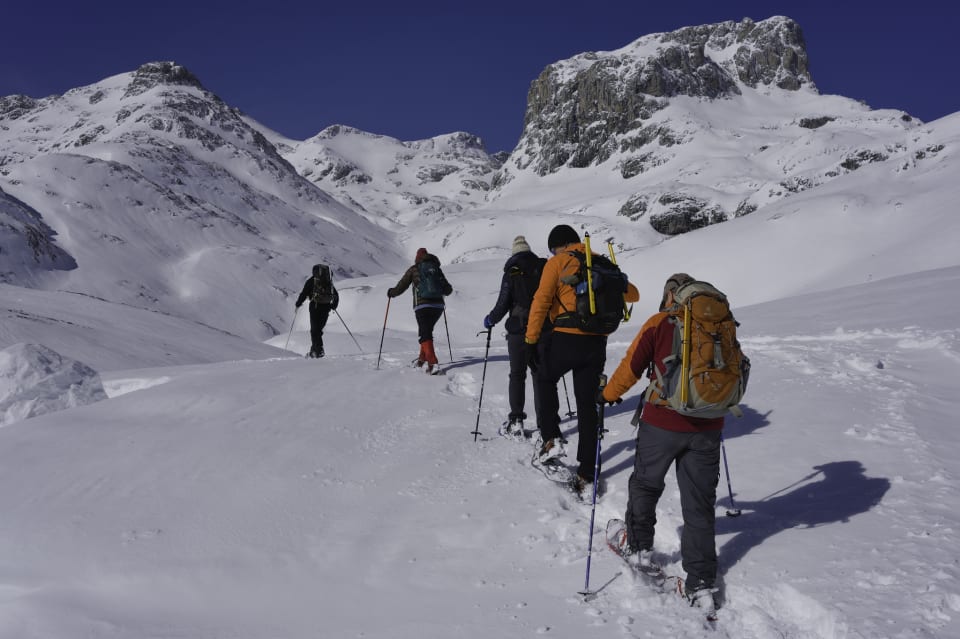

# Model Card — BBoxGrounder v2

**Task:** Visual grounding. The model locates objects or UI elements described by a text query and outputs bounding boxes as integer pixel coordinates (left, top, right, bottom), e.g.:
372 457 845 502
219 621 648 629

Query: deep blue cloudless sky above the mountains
0 0 960 152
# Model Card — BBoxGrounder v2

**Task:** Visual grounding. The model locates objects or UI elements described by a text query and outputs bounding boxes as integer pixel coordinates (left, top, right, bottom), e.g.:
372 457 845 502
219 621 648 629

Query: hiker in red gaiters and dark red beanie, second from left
387 248 453 374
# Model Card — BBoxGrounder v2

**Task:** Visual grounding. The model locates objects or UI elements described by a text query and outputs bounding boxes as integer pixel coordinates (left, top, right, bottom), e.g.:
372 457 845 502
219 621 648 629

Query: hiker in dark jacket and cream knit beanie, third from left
483 235 547 437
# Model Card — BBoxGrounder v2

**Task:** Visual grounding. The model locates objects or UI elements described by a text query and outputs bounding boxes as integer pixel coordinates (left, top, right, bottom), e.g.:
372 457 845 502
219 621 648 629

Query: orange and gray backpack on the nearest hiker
644 281 750 418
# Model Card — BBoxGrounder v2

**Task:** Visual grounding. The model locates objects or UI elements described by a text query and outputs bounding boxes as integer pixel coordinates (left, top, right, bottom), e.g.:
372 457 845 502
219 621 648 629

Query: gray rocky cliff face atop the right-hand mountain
514 18 813 175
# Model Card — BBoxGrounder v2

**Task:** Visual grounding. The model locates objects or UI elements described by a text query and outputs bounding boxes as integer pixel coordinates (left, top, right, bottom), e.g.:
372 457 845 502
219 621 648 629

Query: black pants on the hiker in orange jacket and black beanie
534 331 607 480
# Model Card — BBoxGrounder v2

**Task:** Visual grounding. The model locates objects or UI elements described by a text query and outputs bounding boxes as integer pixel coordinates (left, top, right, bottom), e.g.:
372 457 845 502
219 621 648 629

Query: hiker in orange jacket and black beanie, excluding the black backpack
524 224 639 492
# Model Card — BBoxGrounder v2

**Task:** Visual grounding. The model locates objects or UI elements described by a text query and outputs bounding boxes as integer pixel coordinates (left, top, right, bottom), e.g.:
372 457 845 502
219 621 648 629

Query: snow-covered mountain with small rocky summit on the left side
0 63 402 339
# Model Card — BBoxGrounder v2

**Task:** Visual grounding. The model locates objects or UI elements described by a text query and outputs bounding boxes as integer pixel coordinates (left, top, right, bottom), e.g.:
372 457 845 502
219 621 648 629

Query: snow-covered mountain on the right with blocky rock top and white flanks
490 17 943 235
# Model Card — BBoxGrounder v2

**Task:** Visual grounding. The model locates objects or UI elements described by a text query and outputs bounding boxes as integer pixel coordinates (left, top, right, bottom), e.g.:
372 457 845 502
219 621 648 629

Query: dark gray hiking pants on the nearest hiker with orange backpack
625 421 720 586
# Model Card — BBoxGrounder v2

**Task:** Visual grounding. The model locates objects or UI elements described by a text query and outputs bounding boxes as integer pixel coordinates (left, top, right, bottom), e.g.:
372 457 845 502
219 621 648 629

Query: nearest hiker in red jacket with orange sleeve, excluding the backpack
597 273 724 609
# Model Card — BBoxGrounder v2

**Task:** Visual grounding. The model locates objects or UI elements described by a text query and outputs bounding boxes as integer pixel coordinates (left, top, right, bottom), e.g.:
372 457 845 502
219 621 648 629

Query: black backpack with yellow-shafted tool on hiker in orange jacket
554 251 628 335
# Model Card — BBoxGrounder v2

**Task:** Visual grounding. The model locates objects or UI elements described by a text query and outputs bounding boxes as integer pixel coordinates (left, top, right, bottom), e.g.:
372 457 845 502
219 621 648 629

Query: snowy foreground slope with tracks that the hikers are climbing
0 256 960 639
